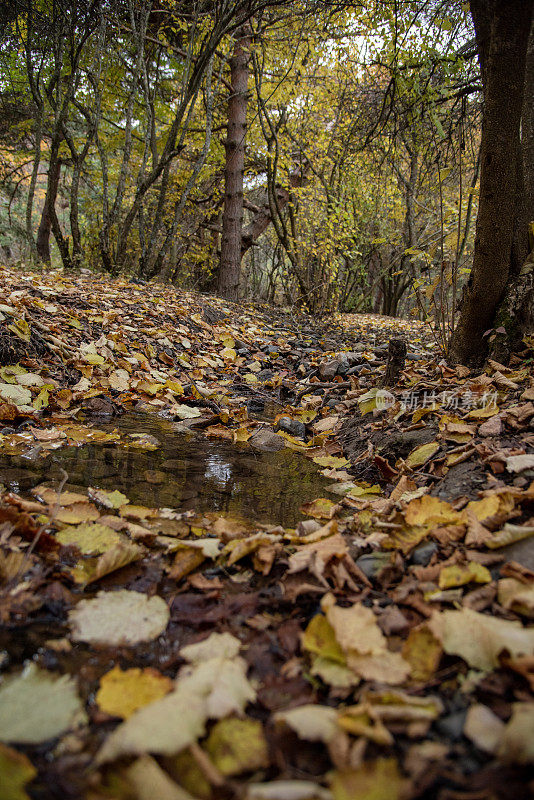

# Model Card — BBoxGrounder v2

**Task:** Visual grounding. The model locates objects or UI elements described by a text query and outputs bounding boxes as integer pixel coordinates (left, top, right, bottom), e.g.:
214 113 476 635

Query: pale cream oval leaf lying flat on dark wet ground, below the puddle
69 589 169 646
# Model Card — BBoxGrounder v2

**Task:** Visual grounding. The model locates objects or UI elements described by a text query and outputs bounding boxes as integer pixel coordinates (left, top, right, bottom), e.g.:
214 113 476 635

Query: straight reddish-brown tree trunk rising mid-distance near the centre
218 26 250 301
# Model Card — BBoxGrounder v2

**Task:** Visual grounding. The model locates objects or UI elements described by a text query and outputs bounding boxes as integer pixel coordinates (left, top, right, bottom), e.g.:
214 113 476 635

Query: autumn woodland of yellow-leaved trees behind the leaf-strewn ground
0 0 534 361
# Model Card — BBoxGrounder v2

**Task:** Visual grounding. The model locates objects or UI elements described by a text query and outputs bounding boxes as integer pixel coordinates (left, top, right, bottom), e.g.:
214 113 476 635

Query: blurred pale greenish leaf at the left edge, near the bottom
0 663 86 744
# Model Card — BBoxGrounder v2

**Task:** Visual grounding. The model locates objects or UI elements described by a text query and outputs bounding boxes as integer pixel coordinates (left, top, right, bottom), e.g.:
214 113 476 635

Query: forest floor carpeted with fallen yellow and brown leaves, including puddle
0 269 534 800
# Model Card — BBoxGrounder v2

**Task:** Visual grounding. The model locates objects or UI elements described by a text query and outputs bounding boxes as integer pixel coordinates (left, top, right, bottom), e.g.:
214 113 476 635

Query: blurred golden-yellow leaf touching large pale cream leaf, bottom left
95 667 174 719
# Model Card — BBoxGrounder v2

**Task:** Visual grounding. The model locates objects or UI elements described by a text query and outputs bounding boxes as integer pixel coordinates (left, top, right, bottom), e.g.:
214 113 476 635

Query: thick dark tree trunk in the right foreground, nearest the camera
449 0 534 365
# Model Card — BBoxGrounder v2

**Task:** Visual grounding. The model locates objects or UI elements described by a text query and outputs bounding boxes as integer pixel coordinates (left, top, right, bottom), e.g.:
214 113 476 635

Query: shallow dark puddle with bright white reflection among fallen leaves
0 412 331 527
